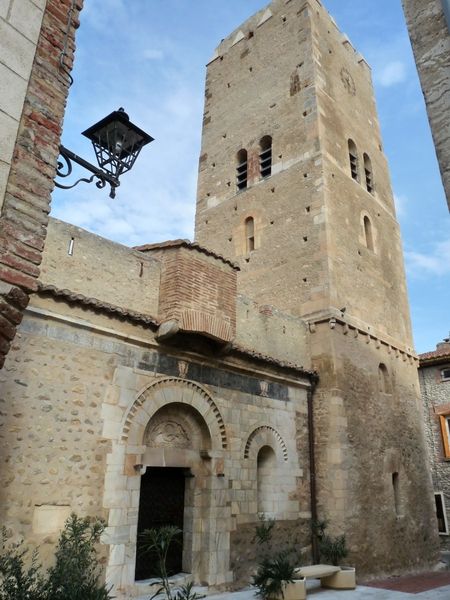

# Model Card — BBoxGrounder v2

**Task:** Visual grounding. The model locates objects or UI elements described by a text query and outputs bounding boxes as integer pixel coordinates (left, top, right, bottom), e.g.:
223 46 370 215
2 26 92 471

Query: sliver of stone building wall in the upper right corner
402 0 450 209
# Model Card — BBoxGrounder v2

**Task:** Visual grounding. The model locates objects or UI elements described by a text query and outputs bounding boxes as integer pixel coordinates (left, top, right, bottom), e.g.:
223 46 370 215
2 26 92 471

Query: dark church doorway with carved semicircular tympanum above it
135 402 211 581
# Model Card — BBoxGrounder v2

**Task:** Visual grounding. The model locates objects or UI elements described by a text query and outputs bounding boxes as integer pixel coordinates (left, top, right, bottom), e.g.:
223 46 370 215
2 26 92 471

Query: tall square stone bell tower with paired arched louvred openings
196 0 437 573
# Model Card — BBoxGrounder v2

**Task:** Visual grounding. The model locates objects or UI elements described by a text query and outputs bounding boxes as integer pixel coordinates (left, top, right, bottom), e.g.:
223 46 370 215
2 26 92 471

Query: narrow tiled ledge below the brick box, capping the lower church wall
38 282 318 379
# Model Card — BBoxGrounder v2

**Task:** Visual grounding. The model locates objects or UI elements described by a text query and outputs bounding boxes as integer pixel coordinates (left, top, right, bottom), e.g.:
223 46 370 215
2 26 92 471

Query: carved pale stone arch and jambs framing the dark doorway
103 377 230 598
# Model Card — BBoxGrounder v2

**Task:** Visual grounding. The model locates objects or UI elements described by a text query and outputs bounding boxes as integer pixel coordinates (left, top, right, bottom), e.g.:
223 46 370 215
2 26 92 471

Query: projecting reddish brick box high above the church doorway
159 247 236 342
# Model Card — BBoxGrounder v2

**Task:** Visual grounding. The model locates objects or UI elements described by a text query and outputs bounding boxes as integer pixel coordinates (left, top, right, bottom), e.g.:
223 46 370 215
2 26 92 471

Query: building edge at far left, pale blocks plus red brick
0 0 82 368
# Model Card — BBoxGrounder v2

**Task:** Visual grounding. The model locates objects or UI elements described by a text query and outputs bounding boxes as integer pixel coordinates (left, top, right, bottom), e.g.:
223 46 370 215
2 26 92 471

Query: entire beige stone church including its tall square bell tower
0 0 438 598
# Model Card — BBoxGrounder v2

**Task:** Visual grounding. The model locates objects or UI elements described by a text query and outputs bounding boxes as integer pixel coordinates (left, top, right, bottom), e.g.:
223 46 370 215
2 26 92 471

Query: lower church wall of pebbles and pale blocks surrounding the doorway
0 294 310 598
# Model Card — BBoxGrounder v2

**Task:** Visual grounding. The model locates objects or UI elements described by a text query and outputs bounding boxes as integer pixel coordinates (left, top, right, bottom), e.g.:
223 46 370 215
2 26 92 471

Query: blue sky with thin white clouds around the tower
52 0 450 352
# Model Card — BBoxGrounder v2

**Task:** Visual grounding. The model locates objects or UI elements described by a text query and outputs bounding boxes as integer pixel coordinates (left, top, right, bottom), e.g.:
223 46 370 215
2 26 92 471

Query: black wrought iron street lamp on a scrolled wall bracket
55 108 153 198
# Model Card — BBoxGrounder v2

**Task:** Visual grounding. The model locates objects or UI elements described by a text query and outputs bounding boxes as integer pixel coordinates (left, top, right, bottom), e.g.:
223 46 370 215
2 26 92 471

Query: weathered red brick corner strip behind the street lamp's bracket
0 0 82 368
